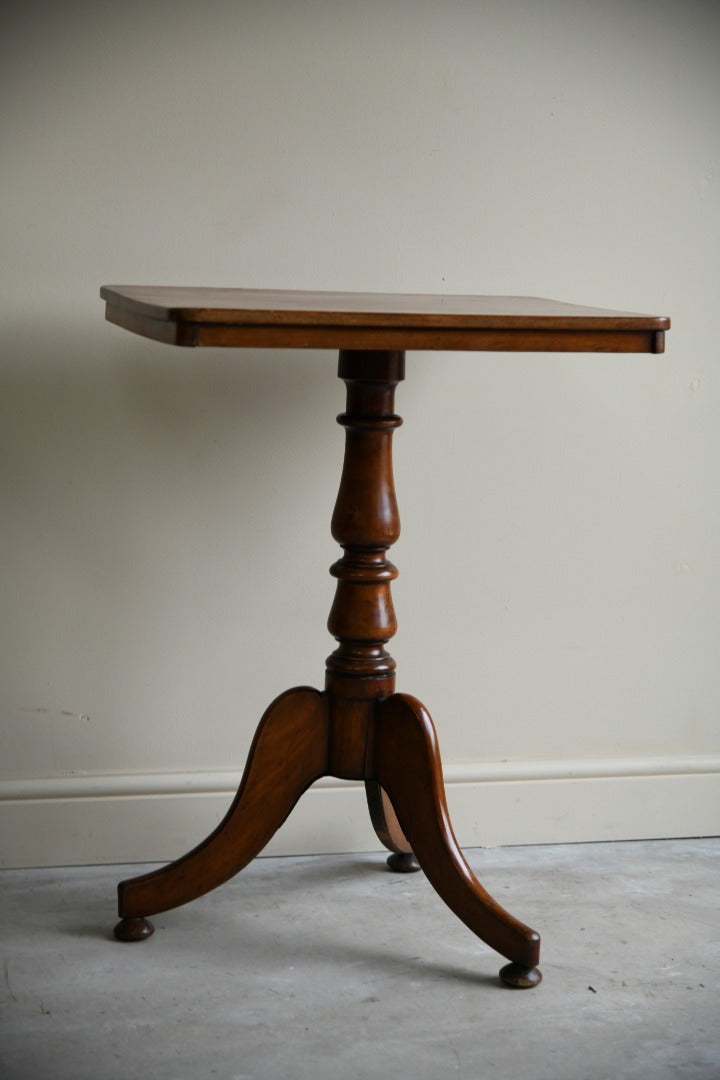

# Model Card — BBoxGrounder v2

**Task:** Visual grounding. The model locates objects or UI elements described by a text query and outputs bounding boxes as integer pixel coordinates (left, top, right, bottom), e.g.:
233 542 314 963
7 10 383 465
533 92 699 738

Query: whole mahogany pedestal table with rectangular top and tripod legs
100 285 670 988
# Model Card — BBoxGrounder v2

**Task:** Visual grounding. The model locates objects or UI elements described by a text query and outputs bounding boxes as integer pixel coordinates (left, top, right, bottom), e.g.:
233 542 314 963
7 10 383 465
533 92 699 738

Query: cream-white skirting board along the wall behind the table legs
0 755 720 867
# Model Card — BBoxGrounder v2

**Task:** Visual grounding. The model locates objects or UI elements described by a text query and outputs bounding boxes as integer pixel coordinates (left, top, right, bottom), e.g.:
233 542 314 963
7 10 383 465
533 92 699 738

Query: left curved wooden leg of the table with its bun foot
114 687 327 941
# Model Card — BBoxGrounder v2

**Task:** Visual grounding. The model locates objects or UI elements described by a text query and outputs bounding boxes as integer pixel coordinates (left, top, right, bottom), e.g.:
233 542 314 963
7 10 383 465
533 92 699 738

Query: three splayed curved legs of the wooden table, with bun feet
114 687 541 988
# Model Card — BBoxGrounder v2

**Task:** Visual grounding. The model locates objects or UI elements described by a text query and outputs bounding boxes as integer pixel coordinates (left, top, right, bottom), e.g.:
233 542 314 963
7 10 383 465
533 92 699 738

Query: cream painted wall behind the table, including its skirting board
0 0 720 865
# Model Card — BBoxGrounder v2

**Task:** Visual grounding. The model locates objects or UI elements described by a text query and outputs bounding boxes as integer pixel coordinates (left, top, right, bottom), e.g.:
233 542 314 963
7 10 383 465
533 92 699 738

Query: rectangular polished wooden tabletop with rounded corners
100 285 670 352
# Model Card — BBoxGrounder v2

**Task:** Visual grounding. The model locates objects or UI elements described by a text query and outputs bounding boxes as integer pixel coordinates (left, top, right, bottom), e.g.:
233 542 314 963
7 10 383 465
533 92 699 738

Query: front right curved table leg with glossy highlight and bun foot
373 693 542 987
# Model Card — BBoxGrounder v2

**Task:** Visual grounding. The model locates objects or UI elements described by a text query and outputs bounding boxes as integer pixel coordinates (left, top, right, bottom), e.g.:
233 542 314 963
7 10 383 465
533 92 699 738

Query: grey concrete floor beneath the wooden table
0 839 720 1080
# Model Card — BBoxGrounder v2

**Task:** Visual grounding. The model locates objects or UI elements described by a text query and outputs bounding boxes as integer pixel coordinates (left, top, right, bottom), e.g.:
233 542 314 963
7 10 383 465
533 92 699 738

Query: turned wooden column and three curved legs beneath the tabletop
116 350 540 987
